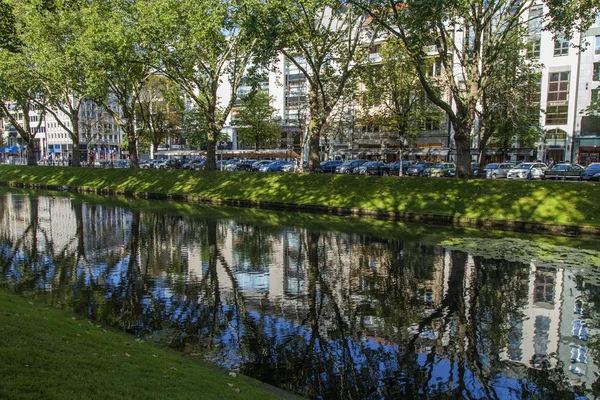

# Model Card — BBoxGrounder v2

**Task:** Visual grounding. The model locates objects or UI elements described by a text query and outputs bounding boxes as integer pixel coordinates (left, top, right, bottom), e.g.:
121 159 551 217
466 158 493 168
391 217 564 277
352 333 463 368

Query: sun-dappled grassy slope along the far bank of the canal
0 166 600 226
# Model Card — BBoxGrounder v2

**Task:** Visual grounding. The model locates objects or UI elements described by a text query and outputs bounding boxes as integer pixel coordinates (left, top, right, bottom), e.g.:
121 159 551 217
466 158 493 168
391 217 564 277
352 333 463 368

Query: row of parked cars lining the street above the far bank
140 159 600 181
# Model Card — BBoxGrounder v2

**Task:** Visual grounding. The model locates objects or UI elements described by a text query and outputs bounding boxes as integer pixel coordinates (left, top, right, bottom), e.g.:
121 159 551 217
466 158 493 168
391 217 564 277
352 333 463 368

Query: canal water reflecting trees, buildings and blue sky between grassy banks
0 189 600 399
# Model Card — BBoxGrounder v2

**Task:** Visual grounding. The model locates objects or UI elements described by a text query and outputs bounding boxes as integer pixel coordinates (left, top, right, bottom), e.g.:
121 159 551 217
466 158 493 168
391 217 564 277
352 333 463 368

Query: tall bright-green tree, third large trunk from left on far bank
81 0 154 168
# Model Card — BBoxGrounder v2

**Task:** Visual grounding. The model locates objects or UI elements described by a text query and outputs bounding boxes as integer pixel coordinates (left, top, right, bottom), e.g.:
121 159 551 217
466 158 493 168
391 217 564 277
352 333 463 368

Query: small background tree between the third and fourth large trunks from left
136 76 183 158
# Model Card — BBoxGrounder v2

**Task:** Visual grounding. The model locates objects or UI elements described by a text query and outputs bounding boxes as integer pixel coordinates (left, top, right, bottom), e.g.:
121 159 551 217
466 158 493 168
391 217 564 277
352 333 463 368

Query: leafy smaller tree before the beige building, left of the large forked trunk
361 38 441 159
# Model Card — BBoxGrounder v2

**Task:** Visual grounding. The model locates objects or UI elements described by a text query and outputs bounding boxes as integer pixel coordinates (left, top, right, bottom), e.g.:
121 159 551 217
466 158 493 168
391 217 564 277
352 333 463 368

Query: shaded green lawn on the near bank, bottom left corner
0 290 286 399
